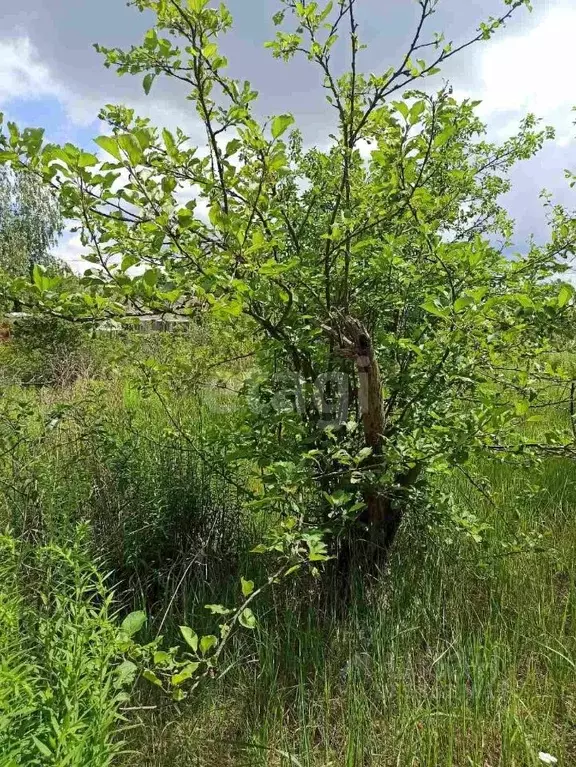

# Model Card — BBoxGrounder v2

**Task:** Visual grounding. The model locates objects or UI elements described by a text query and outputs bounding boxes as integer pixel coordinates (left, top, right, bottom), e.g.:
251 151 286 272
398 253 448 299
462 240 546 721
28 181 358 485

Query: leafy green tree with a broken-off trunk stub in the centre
1 0 574 584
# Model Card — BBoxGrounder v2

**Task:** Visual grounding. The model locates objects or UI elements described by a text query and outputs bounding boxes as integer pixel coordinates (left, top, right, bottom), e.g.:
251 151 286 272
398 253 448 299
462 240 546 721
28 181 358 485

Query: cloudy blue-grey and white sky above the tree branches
0 0 576 267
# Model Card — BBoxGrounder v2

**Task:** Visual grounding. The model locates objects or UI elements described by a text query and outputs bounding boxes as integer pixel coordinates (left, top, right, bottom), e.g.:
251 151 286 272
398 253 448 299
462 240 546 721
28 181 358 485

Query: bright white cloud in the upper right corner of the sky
460 5 576 146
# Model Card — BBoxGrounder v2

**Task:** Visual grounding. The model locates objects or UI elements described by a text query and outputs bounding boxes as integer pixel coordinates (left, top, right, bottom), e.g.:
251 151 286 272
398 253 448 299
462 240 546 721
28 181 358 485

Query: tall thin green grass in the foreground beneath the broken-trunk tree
126 460 576 767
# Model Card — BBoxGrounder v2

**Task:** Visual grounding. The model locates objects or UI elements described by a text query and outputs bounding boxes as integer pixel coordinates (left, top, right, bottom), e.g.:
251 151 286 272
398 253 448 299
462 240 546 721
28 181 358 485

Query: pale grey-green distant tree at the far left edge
0 153 62 275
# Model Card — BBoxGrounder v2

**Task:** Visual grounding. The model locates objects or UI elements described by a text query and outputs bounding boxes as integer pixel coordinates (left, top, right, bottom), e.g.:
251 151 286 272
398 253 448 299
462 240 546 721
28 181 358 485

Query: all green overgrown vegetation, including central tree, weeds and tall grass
0 0 576 767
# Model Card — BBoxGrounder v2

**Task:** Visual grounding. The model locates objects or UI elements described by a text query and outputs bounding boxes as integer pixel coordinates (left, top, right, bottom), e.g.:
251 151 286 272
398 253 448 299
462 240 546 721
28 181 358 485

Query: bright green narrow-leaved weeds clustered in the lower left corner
0 534 125 767
